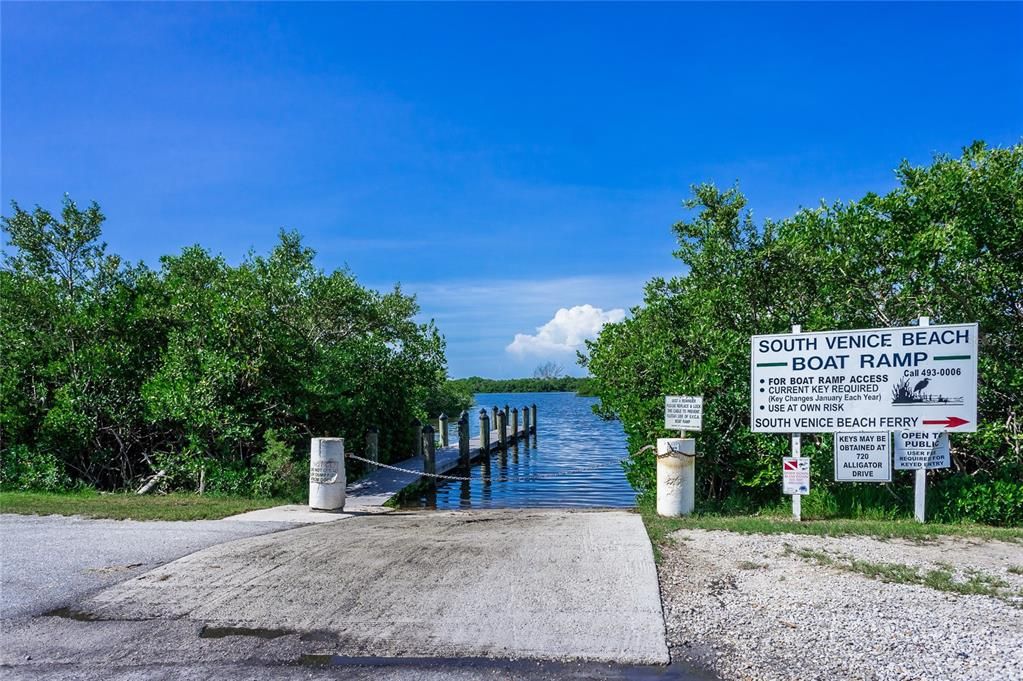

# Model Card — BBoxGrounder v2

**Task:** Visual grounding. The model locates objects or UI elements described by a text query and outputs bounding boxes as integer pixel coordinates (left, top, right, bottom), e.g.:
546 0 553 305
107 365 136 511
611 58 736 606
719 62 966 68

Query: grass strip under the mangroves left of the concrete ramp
0 491 286 520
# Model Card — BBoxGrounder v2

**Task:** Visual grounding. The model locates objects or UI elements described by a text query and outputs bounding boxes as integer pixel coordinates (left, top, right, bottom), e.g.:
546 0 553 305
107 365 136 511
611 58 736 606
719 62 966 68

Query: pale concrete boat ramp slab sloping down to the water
65 510 668 664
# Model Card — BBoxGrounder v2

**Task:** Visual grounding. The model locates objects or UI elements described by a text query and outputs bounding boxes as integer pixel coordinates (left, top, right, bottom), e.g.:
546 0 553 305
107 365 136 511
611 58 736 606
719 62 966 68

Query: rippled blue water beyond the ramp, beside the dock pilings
396 393 635 509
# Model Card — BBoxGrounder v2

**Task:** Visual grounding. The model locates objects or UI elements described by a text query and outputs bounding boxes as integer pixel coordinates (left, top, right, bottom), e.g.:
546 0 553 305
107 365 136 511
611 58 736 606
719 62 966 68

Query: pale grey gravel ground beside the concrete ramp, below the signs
658 530 1023 681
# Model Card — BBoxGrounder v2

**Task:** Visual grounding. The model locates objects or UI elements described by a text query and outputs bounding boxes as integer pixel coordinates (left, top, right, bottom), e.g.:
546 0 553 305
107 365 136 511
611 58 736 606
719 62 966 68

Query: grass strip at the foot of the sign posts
638 496 1023 559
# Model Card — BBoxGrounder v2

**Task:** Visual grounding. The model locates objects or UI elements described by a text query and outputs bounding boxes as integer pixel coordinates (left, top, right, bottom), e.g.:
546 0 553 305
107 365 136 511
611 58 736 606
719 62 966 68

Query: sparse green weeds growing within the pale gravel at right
785 543 1023 605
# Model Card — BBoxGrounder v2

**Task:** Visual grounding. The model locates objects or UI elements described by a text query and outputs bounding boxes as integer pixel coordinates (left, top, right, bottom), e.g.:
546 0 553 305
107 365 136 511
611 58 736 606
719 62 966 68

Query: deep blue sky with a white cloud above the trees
0 2 1023 377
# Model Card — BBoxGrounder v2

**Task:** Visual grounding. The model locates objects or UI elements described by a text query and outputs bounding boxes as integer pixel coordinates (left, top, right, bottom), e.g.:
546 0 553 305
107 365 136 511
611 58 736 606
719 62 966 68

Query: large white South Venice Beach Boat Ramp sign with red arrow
750 324 977 433
